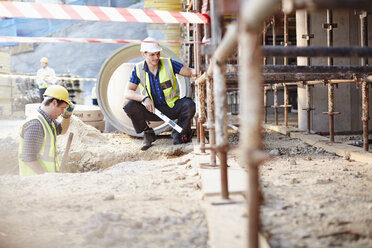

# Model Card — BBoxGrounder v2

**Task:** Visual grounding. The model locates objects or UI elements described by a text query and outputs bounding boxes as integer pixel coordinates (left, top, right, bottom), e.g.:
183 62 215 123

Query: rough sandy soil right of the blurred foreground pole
260 133 372 247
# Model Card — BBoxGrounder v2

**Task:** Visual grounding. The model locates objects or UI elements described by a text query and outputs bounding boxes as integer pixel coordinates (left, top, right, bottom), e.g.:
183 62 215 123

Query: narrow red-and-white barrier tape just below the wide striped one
0 36 204 44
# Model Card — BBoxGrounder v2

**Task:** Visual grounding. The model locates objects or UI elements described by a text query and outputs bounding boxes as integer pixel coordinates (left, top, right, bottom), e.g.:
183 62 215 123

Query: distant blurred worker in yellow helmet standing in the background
36 57 58 102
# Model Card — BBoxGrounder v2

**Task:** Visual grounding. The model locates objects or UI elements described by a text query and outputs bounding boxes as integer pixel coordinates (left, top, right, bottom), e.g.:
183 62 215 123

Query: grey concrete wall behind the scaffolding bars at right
296 10 372 132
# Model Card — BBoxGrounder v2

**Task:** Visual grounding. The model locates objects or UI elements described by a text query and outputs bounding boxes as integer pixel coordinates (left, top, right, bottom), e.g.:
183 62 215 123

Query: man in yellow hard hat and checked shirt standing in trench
18 85 74 176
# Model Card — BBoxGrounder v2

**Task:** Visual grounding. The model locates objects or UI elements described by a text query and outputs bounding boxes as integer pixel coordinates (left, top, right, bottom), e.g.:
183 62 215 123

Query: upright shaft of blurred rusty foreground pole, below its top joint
239 30 263 248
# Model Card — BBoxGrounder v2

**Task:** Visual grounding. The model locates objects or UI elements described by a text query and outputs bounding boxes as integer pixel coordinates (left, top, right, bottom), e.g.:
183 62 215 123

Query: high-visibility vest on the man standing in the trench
18 113 60 176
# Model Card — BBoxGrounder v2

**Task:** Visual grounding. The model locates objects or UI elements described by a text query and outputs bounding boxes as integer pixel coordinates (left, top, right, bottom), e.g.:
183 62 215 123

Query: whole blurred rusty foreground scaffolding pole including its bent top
238 0 281 248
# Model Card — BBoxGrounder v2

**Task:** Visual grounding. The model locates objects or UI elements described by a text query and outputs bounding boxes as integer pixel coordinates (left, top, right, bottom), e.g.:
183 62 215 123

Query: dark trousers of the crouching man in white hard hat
124 97 195 134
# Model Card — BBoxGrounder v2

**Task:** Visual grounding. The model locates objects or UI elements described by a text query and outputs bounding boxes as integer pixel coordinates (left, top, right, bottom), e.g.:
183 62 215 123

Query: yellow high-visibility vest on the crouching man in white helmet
136 58 180 108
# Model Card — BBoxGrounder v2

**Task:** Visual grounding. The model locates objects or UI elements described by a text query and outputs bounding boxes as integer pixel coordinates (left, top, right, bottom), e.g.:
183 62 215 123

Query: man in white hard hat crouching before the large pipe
124 37 195 150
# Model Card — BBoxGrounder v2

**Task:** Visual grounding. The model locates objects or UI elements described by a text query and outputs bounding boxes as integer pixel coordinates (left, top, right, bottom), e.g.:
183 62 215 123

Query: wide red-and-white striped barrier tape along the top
0 1 209 24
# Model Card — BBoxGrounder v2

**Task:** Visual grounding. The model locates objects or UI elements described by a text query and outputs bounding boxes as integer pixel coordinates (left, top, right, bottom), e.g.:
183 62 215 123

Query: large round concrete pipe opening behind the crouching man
97 44 191 137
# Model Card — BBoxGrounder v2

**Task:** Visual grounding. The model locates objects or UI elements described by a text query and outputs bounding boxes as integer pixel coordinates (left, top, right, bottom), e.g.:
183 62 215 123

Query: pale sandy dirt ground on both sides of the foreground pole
0 115 372 248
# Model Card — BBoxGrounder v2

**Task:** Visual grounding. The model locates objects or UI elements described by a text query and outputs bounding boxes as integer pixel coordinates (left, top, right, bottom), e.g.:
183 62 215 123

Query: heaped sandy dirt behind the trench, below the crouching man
0 116 193 174
